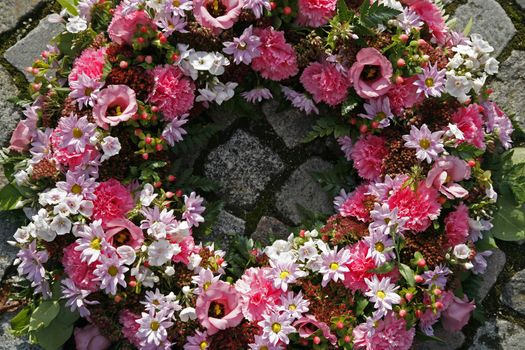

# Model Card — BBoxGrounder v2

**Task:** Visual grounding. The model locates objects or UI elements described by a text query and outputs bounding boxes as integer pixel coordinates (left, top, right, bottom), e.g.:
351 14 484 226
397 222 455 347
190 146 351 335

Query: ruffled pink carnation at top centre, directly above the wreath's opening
252 27 299 81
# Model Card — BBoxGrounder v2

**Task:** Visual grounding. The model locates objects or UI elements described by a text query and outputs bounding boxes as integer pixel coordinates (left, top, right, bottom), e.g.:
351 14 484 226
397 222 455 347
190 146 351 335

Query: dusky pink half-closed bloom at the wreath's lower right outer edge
441 292 476 332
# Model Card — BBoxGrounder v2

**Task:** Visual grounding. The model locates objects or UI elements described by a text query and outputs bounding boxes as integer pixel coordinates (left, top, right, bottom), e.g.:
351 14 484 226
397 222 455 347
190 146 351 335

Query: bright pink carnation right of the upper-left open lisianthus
148 65 195 120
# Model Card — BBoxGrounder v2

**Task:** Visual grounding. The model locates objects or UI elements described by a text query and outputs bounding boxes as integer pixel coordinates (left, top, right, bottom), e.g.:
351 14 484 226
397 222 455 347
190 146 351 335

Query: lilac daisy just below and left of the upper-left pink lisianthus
58 114 96 153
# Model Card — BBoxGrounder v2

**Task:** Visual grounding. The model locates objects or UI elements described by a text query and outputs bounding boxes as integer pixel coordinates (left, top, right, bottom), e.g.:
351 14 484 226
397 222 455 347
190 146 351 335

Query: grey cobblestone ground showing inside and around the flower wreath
0 0 525 350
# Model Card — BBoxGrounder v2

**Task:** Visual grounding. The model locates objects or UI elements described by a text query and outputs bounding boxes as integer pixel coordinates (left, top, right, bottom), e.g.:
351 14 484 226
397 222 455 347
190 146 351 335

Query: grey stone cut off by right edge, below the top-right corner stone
491 51 525 133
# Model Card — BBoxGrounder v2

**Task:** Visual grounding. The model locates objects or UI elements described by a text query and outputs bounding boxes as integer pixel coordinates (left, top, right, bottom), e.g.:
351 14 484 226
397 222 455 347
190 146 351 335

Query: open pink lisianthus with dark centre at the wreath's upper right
349 47 393 98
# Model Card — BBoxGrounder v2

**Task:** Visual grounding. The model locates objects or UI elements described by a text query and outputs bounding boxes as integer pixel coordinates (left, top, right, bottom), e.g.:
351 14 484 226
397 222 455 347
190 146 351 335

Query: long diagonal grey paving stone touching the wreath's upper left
4 17 64 80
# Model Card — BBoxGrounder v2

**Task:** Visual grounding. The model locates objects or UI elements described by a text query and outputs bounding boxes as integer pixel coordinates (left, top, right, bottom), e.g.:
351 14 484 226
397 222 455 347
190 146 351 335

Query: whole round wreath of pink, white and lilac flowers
1 0 525 350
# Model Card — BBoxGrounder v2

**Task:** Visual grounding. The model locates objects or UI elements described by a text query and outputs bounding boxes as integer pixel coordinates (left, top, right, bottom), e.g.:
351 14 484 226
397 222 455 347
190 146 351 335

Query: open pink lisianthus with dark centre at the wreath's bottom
195 281 243 335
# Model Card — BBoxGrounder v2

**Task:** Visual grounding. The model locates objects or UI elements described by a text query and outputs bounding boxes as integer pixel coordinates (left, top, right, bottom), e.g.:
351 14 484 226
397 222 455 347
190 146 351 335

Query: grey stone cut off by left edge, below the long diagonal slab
0 66 21 146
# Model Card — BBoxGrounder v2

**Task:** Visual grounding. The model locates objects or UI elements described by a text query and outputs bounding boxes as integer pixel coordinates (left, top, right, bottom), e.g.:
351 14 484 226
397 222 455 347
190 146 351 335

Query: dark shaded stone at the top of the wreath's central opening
262 101 314 148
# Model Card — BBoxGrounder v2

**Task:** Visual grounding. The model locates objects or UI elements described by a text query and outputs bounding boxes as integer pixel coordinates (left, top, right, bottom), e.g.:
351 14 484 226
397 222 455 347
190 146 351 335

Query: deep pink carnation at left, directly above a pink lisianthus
93 179 135 223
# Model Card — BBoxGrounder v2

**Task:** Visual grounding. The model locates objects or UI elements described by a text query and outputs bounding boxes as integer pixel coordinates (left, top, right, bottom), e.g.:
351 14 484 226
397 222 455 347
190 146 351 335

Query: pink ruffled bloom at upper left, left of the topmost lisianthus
108 4 155 45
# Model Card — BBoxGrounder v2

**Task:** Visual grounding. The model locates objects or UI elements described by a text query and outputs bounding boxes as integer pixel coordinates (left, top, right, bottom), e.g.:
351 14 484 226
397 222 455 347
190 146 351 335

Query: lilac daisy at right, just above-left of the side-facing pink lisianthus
403 124 445 164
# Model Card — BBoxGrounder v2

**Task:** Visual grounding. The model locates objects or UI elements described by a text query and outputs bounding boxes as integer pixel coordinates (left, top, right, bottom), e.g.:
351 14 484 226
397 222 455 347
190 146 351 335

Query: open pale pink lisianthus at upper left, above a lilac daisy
93 85 138 130
